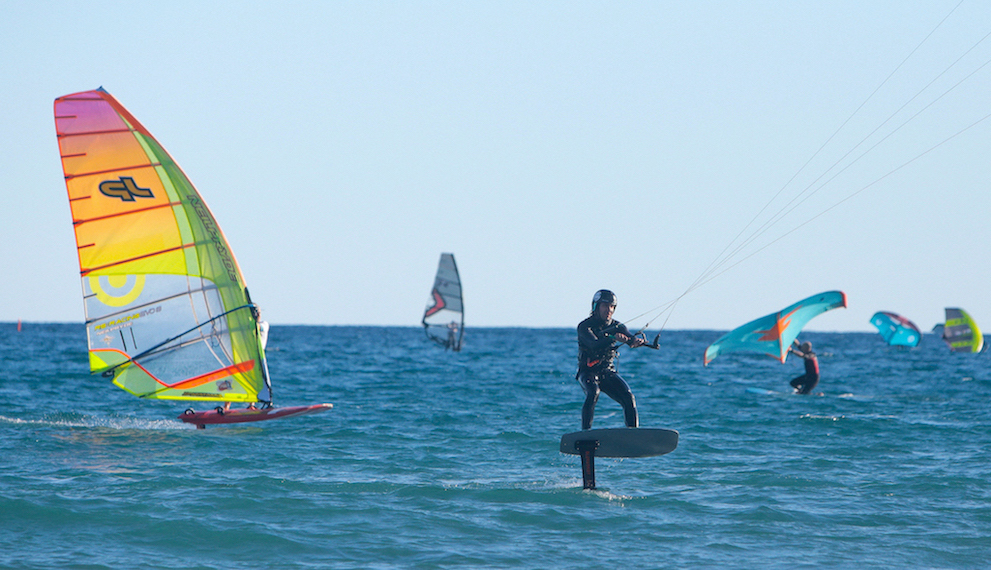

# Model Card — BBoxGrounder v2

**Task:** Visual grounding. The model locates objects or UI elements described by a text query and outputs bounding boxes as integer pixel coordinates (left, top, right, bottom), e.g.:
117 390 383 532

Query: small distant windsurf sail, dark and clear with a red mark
423 253 465 351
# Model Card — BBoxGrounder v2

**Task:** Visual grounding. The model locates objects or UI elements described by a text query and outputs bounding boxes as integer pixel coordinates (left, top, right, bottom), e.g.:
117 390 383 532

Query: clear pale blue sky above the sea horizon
0 0 991 331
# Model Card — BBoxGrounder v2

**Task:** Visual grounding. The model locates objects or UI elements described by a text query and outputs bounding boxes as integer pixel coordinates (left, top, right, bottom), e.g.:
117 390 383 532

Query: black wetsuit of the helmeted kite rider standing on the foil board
575 315 640 429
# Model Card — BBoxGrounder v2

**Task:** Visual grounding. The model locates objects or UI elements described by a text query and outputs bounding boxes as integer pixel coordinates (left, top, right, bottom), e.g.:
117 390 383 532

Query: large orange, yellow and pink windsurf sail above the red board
55 88 272 403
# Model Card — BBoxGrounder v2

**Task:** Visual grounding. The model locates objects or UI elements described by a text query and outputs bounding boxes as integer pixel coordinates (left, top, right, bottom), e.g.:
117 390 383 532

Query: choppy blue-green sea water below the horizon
0 323 991 569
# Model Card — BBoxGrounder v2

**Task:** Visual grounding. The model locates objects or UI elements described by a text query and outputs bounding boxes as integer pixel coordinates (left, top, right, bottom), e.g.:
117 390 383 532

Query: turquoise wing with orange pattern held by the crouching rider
703 291 846 365
